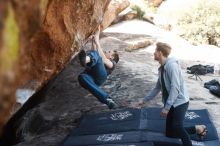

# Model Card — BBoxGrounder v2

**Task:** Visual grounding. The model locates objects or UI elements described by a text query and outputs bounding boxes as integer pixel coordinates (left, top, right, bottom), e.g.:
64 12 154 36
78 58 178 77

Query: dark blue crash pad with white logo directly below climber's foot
72 108 146 135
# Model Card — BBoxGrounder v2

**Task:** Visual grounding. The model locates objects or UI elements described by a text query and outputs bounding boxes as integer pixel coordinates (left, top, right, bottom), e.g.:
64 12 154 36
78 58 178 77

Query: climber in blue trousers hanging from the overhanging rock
78 27 119 109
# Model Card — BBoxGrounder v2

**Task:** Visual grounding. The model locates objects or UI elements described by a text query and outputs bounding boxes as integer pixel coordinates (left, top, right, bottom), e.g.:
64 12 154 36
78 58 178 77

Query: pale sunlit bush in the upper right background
178 0 220 47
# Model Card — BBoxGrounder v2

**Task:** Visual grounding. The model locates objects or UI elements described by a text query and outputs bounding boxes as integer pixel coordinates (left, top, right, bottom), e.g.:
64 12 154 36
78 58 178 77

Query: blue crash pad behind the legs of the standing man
142 108 218 141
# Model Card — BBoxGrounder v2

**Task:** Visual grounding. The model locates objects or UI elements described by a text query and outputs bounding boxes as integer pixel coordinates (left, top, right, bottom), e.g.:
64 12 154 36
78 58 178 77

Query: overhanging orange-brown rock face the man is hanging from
0 0 129 143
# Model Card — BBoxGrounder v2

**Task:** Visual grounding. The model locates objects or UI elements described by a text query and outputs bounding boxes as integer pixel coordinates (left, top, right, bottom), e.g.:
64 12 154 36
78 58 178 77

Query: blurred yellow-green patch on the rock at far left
0 4 19 70
